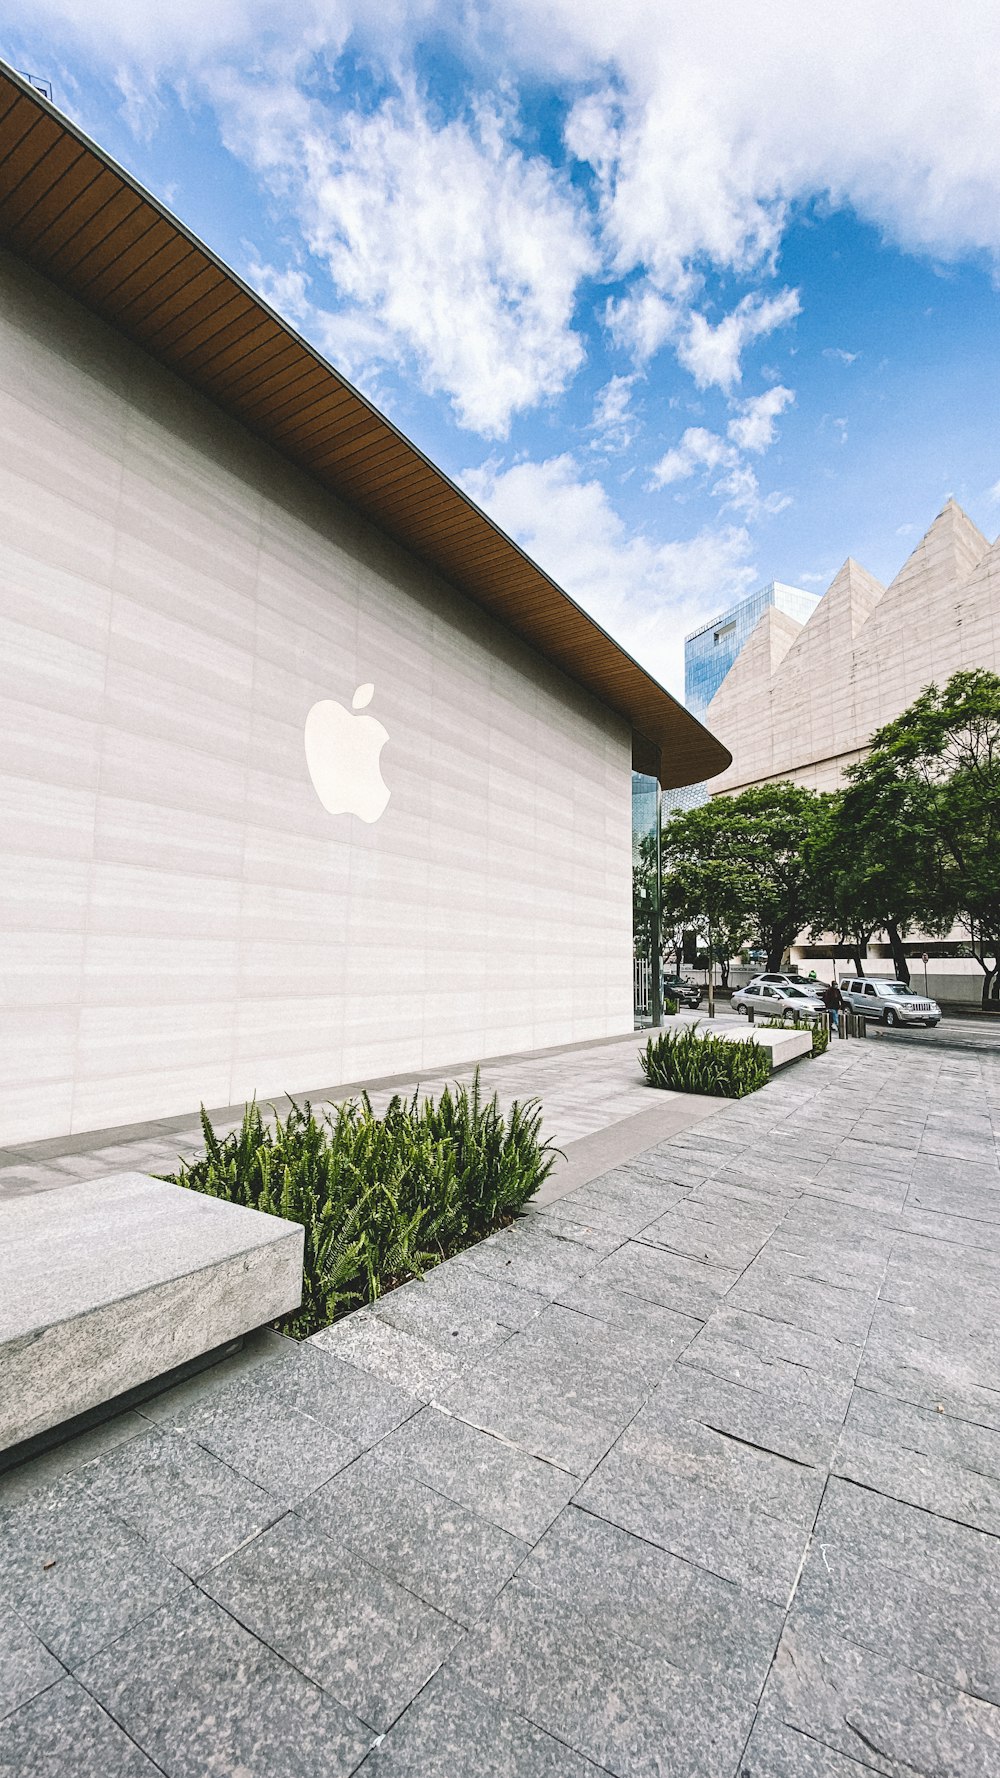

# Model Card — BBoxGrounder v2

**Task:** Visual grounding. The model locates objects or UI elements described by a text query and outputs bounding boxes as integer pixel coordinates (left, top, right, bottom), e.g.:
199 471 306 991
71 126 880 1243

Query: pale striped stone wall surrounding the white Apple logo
0 258 632 1147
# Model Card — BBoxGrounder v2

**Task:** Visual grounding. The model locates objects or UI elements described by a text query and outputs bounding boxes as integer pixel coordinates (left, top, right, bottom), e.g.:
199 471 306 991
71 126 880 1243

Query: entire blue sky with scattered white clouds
0 0 1000 690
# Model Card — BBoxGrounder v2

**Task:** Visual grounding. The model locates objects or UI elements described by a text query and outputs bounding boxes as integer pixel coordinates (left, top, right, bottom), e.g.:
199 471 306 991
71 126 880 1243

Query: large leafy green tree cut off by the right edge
843 669 1000 1006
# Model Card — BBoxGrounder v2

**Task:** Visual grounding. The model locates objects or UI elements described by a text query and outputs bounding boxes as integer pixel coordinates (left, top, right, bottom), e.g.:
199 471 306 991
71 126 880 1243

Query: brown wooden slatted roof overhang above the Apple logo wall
0 62 731 788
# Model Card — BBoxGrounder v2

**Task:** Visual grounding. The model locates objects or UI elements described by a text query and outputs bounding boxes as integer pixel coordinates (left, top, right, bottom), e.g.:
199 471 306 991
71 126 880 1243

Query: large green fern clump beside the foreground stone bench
162 1072 559 1339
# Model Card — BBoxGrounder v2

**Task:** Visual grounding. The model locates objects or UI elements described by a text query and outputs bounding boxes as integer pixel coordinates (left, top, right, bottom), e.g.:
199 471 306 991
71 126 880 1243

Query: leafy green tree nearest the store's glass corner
662 782 827 969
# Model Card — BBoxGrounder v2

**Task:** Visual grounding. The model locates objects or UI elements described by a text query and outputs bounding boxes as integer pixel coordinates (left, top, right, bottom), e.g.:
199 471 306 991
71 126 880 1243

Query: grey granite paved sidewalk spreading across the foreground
0 1042 1000 1778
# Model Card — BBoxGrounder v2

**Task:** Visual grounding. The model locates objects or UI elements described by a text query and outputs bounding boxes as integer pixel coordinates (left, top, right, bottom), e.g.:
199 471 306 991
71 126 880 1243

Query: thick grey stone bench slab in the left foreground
0 1173 304 1453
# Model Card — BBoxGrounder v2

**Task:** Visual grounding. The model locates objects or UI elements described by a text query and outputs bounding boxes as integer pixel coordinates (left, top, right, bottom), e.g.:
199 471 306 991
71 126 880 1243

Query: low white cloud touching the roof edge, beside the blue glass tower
463 455 756 695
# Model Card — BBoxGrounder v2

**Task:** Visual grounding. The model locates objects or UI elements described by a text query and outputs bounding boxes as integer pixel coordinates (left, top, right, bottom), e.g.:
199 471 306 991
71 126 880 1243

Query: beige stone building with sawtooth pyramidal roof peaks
705 500 1000 797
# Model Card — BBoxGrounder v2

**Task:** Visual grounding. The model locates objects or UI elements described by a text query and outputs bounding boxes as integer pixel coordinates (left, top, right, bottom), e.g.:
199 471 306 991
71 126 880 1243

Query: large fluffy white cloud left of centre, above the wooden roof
217 80 594 437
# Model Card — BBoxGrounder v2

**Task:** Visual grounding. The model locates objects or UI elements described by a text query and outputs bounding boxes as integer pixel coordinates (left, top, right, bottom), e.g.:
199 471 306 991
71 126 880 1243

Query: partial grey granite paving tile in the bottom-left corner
0 1678 160 1778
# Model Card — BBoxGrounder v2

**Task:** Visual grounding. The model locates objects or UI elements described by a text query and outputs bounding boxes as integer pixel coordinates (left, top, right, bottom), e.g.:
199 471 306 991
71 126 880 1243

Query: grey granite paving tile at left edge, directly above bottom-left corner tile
0 1478 190 1668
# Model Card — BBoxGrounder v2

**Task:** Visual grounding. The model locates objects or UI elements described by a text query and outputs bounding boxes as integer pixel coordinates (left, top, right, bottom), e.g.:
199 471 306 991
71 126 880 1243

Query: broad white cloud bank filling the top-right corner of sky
516 0 1000 270
